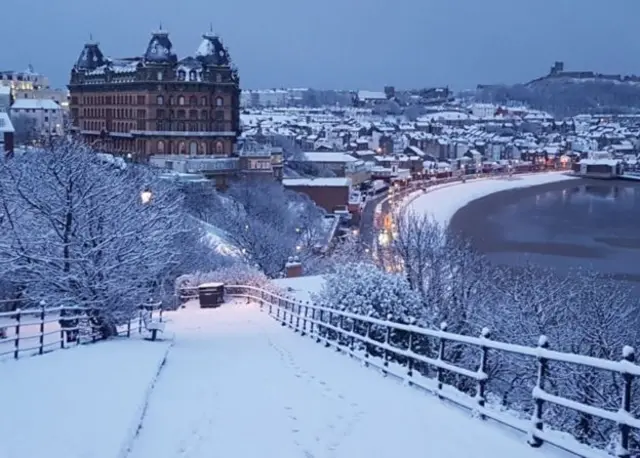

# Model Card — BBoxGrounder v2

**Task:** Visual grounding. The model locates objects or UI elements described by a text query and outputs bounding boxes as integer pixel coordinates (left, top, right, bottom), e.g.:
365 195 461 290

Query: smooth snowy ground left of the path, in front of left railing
0 338 170 458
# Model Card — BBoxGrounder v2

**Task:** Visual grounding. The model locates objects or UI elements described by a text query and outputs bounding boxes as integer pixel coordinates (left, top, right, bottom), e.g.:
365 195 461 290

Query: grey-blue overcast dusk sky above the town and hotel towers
0 0 640 90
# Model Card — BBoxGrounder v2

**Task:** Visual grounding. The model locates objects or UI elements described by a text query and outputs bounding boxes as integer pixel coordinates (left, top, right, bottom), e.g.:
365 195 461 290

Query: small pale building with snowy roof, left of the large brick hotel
11 99 64 137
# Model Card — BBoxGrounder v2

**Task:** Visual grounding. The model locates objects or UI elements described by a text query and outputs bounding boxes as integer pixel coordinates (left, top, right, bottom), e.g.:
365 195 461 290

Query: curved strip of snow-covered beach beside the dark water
406 172 576 225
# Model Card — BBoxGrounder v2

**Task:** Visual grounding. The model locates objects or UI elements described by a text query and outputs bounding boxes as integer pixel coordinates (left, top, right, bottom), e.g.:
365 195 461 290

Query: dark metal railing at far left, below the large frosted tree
0 301 163 359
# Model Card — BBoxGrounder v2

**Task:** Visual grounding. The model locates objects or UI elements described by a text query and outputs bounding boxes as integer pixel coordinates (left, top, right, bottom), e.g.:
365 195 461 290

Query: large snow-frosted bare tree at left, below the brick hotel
0 139 193 337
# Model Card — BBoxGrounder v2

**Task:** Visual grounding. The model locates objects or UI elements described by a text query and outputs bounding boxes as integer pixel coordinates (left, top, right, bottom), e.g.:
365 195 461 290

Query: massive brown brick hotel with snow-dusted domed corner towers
69 30 240 164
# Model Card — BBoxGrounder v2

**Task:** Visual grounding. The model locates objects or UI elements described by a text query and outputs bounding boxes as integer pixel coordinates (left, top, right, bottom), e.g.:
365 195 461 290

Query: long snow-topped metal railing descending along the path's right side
219 285 640 458
